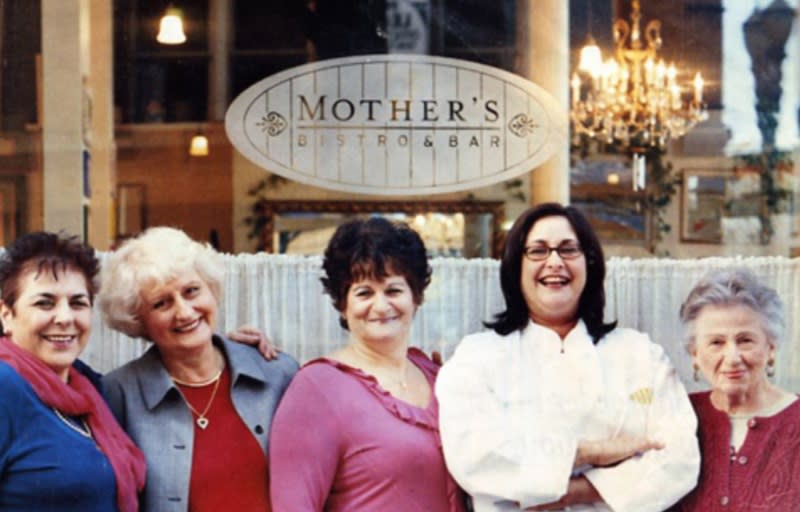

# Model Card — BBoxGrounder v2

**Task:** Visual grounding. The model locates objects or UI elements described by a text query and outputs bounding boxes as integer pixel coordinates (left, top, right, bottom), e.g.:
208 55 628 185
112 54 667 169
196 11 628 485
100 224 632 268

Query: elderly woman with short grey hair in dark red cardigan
676 270 800 512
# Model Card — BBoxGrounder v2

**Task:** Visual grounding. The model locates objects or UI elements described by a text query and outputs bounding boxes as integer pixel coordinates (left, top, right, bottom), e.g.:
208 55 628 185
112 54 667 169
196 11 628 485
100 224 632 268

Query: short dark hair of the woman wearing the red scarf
0 231 100 314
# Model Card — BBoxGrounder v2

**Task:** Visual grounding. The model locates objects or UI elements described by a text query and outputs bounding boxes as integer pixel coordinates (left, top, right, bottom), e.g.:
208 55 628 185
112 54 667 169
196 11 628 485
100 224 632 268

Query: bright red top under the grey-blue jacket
178 367 270 512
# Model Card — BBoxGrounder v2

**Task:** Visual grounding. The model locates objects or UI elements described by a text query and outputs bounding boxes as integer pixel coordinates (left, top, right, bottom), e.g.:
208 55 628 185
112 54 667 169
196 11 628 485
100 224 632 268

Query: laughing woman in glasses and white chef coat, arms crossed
436 203 700 512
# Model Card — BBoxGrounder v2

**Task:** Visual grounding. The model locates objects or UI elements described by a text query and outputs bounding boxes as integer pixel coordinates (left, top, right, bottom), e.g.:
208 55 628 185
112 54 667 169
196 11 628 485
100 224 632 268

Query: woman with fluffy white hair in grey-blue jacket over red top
100 227 297 511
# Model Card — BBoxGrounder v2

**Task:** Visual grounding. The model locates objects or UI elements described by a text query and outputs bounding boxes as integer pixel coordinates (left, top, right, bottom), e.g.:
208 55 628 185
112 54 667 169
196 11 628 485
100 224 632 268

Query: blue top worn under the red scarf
0 362 117 512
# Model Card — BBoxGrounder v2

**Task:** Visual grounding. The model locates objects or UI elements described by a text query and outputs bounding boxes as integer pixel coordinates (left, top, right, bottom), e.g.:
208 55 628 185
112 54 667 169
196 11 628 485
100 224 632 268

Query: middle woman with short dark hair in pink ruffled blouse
270 218 465 512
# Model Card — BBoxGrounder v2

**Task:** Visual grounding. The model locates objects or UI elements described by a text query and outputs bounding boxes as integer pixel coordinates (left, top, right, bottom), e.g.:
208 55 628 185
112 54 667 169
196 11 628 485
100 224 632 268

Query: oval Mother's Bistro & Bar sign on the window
225 55 567 195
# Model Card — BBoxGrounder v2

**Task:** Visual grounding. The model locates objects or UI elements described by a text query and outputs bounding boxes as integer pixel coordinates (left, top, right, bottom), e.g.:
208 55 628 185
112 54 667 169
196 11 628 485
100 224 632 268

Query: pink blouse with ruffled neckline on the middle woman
269 348 465 512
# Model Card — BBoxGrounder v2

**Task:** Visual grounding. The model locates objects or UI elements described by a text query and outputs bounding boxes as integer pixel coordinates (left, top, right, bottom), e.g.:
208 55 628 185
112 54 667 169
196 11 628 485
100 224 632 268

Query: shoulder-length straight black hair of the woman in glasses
484 203 617 343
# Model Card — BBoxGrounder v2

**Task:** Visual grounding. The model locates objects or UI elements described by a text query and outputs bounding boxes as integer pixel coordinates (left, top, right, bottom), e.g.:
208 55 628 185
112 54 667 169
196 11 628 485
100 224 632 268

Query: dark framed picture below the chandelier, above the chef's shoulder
570 153 650 245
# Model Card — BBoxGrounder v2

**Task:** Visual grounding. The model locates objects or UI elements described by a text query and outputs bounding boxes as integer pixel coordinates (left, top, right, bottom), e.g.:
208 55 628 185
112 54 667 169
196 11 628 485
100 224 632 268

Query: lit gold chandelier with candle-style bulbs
570 0 708 148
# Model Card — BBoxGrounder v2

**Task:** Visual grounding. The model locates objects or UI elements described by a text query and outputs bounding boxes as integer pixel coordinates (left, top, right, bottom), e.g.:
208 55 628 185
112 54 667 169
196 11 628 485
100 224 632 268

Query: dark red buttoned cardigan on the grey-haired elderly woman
676 391 800 512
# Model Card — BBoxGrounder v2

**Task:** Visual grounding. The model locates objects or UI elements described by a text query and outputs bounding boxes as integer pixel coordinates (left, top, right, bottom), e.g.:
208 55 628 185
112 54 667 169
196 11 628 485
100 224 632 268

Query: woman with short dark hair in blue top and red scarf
0 232 145 512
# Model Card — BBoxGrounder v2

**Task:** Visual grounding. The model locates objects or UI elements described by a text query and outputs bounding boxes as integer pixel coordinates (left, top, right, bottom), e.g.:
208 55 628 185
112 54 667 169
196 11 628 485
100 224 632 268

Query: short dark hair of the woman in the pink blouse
320 217 431 329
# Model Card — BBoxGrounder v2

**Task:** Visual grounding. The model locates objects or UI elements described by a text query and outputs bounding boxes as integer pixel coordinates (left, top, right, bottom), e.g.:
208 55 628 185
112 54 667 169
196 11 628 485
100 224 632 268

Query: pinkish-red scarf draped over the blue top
0 337 145 512
